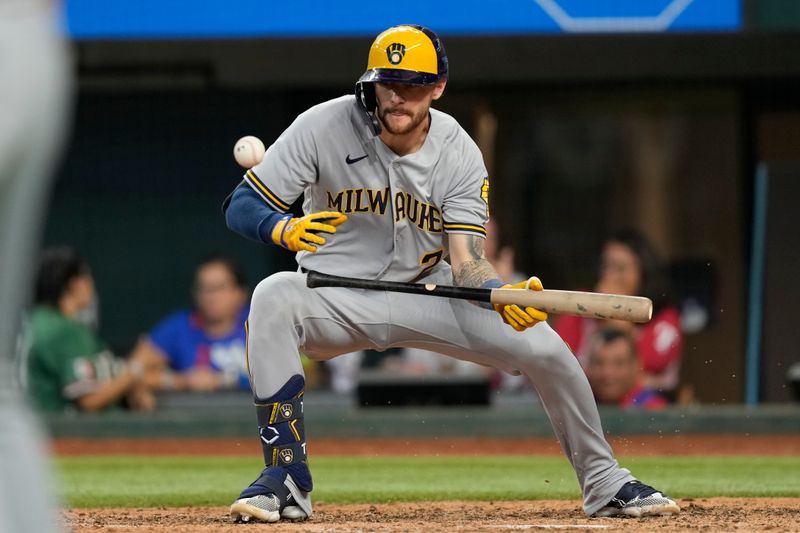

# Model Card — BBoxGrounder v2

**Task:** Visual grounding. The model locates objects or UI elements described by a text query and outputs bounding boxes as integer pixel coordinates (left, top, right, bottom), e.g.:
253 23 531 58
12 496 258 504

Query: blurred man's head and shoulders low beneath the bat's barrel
586 329 667 409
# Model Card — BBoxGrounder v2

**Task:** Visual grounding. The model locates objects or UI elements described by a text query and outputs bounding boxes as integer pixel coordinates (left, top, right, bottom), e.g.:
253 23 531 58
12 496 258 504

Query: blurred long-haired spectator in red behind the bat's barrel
555 230 683 399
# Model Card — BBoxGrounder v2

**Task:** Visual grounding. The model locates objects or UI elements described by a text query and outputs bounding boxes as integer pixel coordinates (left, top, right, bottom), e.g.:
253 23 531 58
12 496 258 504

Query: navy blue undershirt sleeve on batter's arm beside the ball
222 183 287 244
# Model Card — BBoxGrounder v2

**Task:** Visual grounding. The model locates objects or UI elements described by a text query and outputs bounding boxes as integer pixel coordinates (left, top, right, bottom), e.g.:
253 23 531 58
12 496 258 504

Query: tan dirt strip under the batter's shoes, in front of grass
66 498 800 533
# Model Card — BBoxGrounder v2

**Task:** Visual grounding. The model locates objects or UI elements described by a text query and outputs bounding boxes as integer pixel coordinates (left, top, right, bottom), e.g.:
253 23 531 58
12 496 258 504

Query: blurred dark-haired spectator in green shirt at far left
26 248 155 411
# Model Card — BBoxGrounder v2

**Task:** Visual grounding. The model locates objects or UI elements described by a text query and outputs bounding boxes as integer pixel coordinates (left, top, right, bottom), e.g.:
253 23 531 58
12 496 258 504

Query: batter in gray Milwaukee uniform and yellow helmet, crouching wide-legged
224 25 679 522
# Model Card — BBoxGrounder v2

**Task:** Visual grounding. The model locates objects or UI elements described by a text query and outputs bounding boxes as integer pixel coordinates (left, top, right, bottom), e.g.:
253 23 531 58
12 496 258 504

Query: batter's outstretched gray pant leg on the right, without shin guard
388 271 634 514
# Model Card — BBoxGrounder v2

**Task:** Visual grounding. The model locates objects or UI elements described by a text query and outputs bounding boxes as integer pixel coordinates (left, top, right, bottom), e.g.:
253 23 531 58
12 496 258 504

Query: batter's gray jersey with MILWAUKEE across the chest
245 95 489 281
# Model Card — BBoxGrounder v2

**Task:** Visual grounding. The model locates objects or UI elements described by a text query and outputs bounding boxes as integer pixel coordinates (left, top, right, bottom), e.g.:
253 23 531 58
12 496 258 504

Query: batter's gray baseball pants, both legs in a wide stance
248 269 633 514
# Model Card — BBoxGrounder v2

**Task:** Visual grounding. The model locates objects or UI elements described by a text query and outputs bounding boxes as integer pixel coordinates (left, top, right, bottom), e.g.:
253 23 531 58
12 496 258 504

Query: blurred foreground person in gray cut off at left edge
0 0 70 533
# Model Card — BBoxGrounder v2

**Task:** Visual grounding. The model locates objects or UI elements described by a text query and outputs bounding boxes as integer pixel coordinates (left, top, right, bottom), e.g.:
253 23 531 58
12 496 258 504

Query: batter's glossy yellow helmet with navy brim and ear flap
356 24 448 134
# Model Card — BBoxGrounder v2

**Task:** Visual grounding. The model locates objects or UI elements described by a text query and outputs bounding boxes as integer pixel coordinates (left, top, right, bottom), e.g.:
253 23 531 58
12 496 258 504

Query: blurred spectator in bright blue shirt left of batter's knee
134 256 250 391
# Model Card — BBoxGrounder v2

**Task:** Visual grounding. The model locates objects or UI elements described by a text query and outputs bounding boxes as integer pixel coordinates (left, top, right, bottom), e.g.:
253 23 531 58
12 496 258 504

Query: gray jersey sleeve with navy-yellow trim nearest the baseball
244 108 319 213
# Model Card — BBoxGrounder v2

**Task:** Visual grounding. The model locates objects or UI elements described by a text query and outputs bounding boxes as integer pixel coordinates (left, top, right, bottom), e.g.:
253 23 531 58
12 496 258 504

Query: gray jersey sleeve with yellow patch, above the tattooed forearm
442 132 489 237
